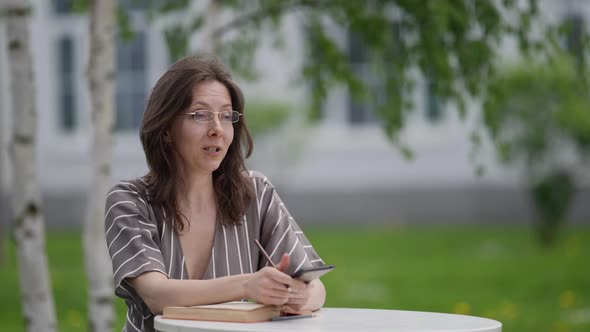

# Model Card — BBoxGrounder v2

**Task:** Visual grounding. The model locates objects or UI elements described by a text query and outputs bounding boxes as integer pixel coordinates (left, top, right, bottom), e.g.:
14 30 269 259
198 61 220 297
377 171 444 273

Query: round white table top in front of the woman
154 308 502 332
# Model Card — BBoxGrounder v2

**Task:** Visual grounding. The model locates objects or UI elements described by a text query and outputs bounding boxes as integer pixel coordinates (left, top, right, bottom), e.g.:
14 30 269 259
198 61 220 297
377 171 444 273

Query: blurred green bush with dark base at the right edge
483 55 590 245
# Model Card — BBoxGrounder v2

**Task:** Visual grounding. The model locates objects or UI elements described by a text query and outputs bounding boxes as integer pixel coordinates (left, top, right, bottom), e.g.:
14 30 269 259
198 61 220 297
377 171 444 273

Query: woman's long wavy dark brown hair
139 56 254 231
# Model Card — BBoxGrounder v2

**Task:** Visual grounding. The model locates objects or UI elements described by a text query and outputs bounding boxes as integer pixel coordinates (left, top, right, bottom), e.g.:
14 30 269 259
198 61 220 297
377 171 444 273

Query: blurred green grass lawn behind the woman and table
0 226 590 332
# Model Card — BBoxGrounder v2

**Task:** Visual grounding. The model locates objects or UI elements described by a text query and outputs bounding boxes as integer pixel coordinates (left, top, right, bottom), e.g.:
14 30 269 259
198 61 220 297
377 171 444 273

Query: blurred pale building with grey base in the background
0 0 590 225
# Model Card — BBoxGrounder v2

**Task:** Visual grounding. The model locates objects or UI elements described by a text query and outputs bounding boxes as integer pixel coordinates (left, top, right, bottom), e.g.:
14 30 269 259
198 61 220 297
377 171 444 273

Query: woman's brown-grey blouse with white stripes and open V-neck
105 171 324 332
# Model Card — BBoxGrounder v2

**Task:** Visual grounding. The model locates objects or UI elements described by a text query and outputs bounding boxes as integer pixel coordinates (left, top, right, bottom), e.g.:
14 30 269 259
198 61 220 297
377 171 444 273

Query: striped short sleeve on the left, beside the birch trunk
105 182 168 295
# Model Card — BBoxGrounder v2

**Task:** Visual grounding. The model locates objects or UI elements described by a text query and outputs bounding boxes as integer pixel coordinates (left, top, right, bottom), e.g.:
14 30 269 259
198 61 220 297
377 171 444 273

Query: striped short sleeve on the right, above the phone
252 172 324 275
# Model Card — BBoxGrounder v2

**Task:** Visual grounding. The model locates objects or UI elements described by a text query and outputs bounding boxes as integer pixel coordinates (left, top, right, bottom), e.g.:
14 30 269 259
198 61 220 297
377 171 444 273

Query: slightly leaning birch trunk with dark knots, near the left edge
4 1 56 332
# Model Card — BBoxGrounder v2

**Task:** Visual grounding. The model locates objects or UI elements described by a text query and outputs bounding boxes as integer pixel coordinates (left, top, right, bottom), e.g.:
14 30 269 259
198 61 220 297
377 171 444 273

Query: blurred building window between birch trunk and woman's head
116 31 147 130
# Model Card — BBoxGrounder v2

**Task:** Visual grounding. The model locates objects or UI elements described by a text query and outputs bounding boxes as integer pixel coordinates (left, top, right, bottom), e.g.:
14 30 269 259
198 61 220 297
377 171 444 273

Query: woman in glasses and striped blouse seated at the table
105 57 325 331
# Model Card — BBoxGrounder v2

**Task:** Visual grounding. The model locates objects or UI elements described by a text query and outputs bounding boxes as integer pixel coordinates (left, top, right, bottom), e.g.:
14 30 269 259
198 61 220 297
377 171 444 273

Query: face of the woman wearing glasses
169 81 234 176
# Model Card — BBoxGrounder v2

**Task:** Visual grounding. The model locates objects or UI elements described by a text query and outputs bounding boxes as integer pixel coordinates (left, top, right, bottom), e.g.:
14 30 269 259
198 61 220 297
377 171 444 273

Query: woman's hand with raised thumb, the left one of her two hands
245 254 306 305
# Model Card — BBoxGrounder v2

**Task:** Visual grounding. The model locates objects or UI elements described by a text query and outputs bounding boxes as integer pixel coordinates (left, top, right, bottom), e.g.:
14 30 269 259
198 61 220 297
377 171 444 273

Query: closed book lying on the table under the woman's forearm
162 301 313 323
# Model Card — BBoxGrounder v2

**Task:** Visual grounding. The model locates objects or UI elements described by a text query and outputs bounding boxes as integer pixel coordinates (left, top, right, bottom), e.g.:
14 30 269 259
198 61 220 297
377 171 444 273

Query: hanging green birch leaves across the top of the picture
113 0 552 132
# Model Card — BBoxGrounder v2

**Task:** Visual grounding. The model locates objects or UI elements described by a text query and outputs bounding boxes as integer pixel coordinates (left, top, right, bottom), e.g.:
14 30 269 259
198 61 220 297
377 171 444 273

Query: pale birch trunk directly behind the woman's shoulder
84 0 117 332
